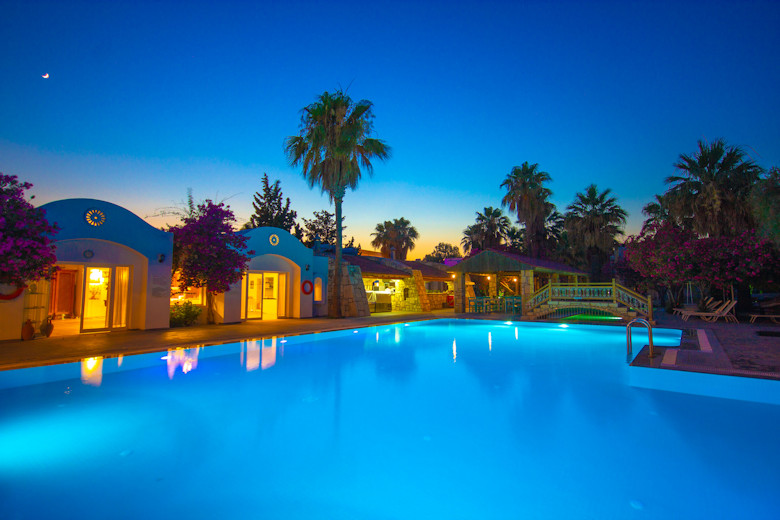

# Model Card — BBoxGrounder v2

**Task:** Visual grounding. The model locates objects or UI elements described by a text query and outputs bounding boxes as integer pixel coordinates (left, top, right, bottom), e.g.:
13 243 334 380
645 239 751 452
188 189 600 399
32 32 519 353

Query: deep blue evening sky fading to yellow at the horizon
0 0 780 258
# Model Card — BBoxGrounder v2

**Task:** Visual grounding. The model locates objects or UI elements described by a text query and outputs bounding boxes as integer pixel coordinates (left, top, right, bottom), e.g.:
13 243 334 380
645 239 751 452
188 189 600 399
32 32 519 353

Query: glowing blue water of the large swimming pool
0 320 780 519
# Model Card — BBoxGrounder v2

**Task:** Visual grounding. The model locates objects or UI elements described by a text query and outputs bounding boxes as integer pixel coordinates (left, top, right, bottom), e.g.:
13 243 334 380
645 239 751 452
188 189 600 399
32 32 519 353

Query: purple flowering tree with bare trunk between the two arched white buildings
169 200 254 323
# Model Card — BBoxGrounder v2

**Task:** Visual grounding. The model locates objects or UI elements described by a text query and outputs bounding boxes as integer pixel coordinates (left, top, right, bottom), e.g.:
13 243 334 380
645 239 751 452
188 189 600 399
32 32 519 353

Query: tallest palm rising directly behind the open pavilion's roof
501 161 555 257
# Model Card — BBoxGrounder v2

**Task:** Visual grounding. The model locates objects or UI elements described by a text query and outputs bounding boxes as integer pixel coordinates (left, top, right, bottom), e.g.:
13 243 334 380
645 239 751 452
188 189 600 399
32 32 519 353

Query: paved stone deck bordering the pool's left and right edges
0 309 780 380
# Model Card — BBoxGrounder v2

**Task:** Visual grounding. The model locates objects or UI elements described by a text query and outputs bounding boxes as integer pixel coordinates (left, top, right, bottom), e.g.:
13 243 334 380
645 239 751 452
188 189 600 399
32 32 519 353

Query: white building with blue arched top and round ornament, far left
0 199 173 340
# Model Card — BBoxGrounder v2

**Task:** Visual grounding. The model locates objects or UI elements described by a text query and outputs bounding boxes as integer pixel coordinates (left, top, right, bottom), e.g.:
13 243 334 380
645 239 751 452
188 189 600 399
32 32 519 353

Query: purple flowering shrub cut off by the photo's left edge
0 173 59 287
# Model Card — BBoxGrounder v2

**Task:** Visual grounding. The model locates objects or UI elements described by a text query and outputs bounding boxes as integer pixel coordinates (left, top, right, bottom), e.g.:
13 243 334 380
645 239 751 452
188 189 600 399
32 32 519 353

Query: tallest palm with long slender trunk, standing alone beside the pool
284 90 390 318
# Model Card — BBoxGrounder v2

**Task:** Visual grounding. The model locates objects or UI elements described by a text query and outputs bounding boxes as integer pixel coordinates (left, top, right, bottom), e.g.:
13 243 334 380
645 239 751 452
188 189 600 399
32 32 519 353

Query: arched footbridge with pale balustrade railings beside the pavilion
524 280 653 321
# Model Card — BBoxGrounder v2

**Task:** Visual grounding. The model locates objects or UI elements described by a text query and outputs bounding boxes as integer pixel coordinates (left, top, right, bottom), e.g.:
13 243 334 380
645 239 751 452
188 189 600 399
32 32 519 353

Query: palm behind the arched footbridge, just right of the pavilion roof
565 184 627 280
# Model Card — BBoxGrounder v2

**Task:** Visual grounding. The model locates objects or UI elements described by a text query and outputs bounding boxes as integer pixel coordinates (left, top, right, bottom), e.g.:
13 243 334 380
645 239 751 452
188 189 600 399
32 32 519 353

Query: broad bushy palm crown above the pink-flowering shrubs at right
664 139 764 236
